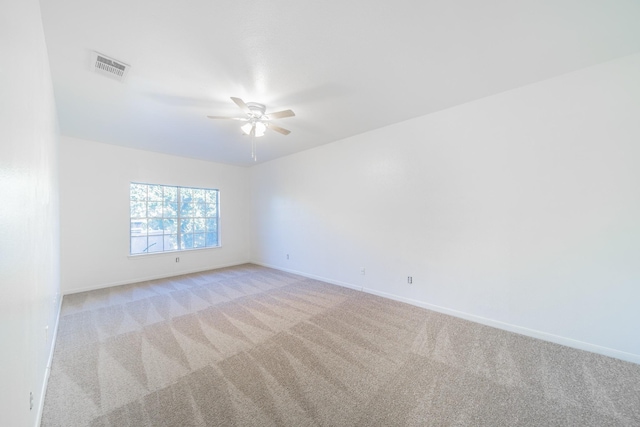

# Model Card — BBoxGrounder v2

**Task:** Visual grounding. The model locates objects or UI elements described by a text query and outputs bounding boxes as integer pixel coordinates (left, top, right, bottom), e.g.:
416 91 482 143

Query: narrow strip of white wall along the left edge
0 0 59 427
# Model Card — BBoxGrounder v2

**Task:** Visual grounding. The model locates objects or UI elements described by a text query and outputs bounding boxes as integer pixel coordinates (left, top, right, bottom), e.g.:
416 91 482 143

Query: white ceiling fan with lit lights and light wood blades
207 96 295 161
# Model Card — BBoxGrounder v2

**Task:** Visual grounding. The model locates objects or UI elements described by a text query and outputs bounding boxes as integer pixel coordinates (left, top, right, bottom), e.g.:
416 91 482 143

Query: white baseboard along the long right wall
252 261 640 364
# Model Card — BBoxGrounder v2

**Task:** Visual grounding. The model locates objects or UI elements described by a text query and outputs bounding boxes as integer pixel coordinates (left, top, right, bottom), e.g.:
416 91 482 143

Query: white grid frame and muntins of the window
129 181 222 257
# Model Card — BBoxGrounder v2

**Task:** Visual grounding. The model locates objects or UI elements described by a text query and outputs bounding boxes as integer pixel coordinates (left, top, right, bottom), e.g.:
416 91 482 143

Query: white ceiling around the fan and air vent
41 0 640 166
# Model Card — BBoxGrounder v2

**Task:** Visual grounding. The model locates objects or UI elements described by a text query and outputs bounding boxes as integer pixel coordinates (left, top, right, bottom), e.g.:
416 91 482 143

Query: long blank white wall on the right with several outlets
251 54 640 363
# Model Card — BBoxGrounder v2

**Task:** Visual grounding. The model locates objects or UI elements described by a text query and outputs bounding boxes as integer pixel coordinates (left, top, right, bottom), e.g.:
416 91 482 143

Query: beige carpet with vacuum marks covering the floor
42 265 640 427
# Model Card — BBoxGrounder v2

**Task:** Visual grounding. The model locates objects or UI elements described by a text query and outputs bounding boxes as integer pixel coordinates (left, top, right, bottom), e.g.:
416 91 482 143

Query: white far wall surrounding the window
60 137 249 294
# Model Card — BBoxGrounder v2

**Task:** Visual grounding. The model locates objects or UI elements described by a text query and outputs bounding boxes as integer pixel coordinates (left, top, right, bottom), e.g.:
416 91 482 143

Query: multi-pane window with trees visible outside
129 182 220 255
